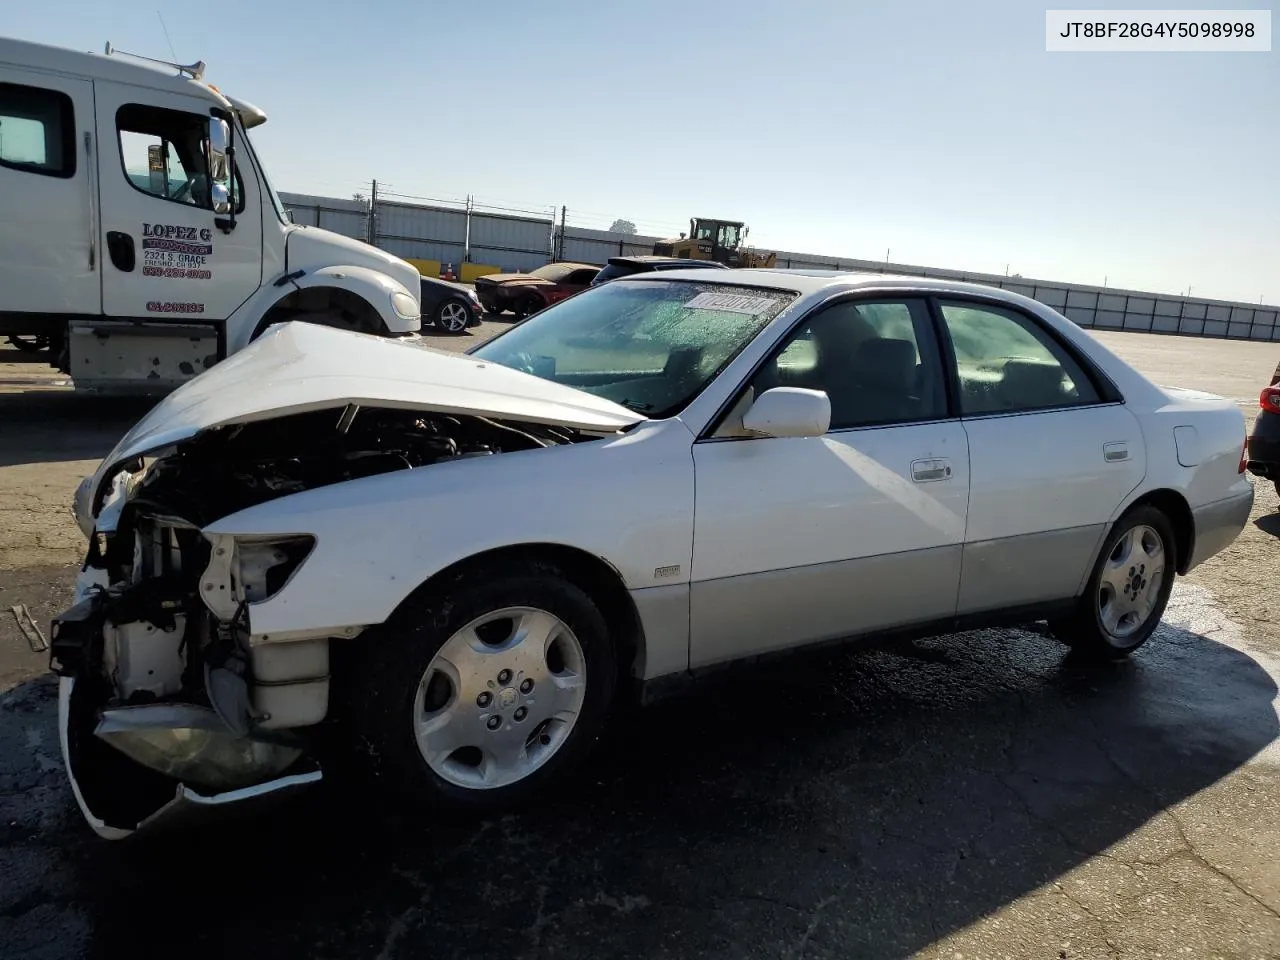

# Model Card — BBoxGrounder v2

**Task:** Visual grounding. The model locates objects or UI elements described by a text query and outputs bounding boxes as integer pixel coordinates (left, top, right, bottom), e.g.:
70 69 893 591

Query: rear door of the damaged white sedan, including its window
937 300 1146 614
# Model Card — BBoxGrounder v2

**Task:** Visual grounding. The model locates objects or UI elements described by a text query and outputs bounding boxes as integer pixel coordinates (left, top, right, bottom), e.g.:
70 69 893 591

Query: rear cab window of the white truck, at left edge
0 83 76 178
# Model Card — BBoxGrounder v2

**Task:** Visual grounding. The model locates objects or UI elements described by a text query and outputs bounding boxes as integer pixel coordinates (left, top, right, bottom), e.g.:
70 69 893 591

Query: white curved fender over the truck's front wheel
227 265 422 356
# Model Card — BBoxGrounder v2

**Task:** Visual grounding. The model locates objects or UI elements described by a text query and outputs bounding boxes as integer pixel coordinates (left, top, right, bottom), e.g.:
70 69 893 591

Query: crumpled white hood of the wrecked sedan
90 323 646 512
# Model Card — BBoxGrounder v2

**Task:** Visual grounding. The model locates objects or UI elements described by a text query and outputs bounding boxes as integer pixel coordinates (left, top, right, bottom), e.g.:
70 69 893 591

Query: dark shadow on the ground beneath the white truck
0 390 156 467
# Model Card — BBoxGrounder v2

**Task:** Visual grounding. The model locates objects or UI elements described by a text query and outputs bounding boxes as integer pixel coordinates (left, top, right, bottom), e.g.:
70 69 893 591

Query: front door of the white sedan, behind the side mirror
690 300 969 667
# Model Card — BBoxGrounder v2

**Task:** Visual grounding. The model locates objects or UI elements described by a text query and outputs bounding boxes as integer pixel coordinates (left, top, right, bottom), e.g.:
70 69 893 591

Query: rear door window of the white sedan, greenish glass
941 303 1100 416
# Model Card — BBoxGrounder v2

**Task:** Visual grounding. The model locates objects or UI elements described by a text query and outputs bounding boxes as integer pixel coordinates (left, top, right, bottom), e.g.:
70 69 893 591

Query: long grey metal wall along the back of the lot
280 193 1280 342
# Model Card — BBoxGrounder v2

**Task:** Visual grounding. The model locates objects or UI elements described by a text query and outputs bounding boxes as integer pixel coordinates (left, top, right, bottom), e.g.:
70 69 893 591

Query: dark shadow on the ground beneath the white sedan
19 616 1277 960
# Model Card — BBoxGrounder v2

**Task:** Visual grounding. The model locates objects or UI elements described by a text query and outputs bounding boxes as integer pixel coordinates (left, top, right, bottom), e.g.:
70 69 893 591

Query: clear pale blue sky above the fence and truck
0 0 1280 303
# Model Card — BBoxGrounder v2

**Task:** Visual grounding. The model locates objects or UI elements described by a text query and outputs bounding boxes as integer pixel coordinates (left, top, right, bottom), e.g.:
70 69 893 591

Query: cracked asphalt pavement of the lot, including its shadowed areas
0 326 1280 960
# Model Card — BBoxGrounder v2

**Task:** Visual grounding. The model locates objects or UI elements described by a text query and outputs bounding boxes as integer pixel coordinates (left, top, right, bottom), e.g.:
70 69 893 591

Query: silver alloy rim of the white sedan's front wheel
413 607 586 790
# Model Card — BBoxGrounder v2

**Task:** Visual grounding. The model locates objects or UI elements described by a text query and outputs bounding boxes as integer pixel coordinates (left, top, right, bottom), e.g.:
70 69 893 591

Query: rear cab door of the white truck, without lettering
0 65 101 314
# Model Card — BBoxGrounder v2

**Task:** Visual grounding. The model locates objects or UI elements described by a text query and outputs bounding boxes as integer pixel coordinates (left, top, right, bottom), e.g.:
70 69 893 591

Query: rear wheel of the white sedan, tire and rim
1050 506 1176 660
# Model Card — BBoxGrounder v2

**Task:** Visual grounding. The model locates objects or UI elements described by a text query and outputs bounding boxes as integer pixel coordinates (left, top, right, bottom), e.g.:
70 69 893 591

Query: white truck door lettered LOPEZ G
95 81 262 320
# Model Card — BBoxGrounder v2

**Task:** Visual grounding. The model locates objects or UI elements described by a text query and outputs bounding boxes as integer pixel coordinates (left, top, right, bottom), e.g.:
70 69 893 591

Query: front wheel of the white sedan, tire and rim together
348 564 617 817
